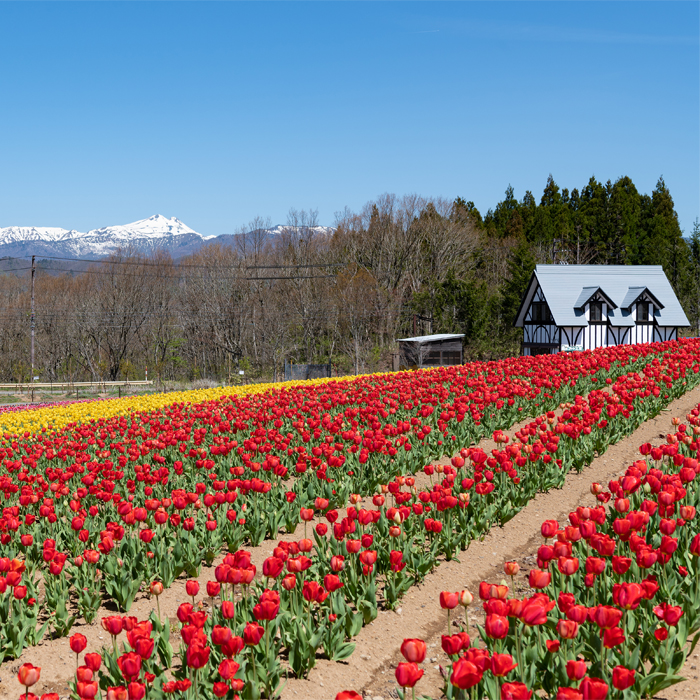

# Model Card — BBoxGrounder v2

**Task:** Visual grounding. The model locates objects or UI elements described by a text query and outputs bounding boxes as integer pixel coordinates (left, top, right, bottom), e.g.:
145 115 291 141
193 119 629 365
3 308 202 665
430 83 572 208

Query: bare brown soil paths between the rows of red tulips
0 387 700 700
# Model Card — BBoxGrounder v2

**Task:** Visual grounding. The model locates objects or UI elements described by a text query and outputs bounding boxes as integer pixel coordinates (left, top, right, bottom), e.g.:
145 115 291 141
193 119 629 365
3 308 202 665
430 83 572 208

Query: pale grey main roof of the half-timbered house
515 265 690 327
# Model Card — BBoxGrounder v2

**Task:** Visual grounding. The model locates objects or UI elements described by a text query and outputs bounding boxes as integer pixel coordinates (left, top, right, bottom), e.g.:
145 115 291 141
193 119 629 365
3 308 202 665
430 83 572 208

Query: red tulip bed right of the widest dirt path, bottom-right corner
382 407 700 700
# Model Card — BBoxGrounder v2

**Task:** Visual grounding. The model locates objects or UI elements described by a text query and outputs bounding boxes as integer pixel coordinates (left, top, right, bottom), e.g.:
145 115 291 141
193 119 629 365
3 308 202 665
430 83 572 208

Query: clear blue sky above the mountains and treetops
0 0 700 235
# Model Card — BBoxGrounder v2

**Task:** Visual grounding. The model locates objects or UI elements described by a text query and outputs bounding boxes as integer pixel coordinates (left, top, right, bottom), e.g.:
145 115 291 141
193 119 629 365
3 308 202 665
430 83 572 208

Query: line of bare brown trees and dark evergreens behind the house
0 176 700 381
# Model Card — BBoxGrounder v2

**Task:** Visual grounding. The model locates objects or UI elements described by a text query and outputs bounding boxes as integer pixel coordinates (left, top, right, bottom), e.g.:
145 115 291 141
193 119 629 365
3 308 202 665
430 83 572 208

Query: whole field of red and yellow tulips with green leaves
0 339 700 700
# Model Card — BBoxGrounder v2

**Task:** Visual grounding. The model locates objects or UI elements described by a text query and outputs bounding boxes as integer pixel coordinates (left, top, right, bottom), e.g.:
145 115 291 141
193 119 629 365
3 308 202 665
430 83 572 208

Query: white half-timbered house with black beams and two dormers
515 265 690 355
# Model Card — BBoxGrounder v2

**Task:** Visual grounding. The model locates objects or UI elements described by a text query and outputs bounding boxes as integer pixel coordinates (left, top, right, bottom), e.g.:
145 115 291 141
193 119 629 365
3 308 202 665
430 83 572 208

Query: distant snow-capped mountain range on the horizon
0 214 335 260
